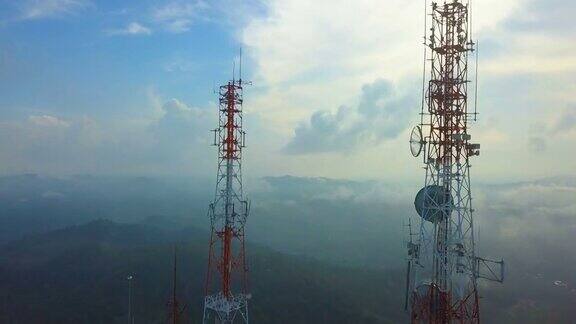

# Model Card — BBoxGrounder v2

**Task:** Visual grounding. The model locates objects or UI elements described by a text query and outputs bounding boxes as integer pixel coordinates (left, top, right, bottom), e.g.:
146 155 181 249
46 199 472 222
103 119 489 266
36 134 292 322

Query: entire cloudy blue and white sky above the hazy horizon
0 0 576 181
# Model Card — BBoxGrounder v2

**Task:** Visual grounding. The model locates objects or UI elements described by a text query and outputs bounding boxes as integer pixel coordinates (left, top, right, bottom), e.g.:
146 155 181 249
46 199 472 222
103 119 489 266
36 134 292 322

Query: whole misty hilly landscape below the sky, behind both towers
0 175 576 323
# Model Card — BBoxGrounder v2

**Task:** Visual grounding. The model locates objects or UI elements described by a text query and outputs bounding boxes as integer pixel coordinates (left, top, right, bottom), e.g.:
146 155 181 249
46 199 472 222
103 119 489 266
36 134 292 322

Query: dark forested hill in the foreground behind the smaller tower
0 220 404 323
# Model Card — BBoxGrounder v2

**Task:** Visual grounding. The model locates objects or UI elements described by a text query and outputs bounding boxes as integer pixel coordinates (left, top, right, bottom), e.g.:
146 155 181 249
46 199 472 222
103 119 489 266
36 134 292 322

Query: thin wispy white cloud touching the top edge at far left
20 0 92 20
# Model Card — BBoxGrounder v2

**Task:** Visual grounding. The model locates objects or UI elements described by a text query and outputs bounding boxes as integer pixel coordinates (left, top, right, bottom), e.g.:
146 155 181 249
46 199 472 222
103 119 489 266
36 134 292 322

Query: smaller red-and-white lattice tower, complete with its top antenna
202 55 250 323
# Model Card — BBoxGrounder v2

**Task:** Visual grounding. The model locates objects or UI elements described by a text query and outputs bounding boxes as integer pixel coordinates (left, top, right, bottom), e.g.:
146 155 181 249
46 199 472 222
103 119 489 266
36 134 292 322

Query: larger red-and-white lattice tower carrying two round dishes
405 0 504 323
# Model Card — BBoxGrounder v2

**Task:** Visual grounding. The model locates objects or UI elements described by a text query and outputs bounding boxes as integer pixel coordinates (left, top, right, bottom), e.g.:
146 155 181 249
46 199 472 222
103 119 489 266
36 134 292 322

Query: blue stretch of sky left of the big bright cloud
0 1 245 116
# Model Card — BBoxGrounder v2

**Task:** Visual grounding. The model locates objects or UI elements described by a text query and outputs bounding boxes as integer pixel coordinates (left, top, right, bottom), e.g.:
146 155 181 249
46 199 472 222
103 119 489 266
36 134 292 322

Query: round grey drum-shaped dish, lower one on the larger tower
414 185 452 223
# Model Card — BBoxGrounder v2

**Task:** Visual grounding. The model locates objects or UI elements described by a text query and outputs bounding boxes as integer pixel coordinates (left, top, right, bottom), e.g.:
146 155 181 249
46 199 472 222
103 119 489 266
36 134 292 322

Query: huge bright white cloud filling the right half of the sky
231 0 576 177
